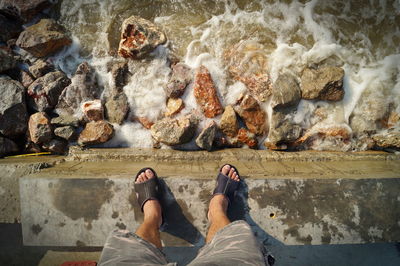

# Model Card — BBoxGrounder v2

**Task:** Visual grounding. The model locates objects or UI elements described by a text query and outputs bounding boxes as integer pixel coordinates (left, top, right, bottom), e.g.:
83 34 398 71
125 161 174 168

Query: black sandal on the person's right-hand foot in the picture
213 164 240 204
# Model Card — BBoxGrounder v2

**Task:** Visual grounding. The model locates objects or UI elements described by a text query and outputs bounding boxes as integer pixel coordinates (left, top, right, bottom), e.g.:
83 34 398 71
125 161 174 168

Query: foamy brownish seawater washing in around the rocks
49 0 400 150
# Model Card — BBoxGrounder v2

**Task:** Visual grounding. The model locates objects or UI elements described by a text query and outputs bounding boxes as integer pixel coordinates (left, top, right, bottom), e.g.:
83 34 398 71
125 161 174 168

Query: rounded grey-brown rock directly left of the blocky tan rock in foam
271 74 301 108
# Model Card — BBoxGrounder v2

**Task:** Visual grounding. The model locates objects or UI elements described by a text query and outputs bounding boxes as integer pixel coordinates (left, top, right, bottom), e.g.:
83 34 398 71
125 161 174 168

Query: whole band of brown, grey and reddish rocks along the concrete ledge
0 0 400 156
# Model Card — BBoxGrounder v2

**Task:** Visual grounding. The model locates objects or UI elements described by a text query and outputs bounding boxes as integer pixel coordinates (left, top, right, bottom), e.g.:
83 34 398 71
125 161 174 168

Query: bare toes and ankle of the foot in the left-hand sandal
135 169 162 227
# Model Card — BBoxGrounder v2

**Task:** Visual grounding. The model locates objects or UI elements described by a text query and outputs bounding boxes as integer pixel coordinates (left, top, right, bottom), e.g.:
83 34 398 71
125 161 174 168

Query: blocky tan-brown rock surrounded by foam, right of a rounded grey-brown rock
301 67 344 101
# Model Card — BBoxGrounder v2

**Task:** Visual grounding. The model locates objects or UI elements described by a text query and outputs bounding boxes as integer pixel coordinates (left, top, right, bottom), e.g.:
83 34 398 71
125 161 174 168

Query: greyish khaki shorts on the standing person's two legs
99 221 273 266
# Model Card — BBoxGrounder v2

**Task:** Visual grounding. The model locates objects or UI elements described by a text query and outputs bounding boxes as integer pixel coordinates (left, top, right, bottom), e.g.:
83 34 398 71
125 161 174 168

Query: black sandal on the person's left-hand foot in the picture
134 167 160 212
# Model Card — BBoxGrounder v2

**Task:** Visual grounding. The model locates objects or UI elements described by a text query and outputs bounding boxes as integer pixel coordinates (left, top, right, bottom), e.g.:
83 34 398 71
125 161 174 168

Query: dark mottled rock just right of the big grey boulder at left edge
28 71 71 112
